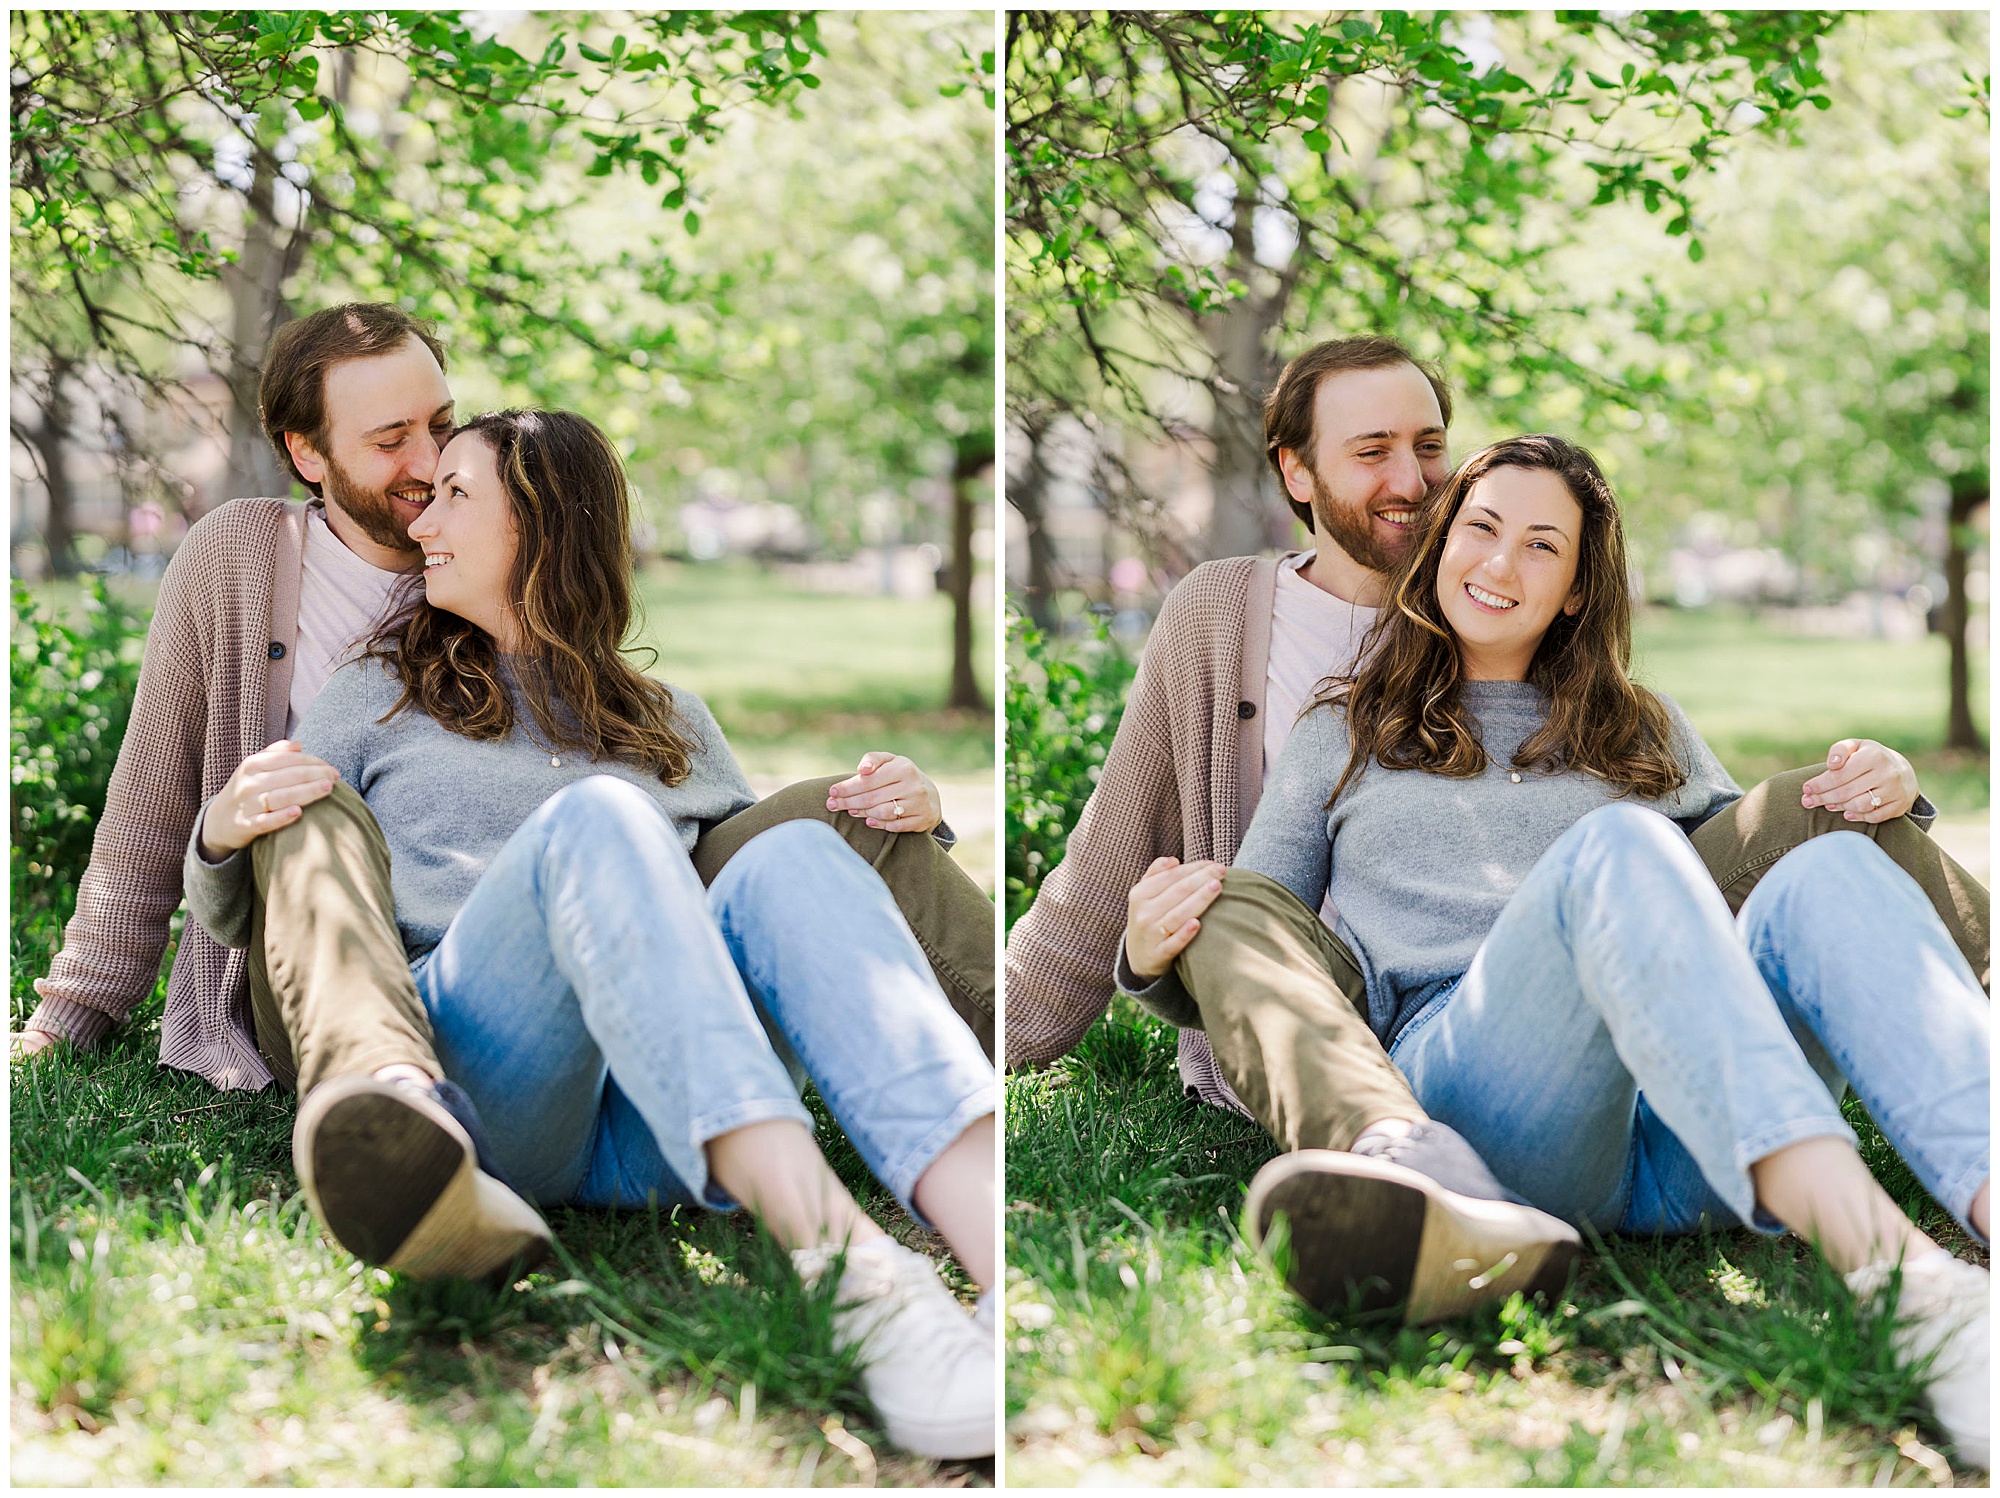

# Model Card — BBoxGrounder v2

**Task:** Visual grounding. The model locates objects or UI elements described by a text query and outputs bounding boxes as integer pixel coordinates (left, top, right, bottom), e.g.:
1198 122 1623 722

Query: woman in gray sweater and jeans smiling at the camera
1168 436 1990 1466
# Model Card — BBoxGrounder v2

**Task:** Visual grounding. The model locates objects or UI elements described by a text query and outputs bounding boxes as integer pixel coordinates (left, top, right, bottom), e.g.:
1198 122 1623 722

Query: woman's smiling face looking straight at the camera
1438 466 1584 682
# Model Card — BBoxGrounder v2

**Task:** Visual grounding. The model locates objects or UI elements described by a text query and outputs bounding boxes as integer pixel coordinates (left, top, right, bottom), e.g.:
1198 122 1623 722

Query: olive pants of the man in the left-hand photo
248 776 998 1094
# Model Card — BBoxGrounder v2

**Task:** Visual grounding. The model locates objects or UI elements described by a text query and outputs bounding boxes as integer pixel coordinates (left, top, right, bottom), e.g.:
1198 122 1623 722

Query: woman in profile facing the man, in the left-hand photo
188 412 996 1458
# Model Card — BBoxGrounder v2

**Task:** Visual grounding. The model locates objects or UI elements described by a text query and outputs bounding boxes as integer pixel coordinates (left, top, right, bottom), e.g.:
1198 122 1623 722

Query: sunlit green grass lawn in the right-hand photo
1006 612 1988 1486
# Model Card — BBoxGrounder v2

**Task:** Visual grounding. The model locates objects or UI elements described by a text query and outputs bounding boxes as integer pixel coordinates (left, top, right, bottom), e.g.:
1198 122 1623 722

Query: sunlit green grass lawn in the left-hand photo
10 568 992 1486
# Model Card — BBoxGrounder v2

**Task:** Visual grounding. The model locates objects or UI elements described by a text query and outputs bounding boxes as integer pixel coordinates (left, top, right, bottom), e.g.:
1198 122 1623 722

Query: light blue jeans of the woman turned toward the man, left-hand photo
412 776 998 1214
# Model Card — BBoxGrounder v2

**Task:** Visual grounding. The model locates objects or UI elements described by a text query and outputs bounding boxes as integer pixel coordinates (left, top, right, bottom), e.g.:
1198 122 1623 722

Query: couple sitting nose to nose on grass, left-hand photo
16 304 996 1458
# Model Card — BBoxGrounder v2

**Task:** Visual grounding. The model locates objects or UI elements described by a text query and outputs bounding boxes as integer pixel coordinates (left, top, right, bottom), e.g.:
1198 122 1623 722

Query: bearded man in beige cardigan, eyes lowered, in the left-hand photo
16 304 992 1276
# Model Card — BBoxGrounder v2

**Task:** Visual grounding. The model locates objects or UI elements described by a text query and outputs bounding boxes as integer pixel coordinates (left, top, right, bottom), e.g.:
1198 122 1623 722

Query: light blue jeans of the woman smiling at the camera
1390 806 1992 1232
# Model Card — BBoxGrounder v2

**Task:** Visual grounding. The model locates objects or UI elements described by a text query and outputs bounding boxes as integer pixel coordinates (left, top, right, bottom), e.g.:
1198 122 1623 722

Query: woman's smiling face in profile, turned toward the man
410 432 516 650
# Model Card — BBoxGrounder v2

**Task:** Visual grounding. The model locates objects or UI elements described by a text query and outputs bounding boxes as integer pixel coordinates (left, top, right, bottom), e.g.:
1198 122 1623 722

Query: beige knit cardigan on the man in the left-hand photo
26 500 306 1088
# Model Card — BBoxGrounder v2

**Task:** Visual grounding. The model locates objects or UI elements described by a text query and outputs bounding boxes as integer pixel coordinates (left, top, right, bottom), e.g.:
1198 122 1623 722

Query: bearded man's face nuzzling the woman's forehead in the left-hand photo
286 338 452 568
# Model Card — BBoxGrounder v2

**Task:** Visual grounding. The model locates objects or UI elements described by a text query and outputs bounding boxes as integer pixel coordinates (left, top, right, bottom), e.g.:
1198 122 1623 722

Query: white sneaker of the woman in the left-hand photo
792 1238 998 1460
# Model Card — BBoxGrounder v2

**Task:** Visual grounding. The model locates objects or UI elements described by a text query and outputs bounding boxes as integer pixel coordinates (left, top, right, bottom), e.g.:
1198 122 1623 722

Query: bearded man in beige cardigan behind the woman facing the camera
1006 336 1988 1322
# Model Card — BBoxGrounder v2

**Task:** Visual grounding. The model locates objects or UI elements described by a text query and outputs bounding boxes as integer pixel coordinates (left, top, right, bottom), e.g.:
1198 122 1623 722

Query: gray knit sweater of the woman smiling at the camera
1236 682 1742 1044
